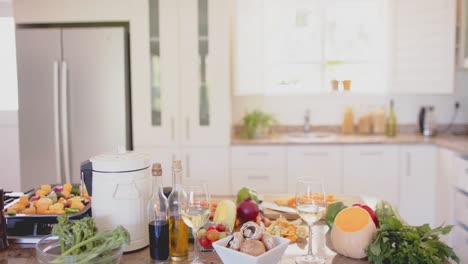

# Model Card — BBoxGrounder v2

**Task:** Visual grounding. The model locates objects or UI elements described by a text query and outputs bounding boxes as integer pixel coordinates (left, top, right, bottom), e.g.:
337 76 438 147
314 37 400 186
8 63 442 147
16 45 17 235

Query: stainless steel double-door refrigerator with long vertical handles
16 25 132 190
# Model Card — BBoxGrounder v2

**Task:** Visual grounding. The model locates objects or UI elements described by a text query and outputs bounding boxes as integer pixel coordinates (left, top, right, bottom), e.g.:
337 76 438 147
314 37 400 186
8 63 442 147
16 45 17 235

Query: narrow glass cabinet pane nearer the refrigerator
149 0 161 126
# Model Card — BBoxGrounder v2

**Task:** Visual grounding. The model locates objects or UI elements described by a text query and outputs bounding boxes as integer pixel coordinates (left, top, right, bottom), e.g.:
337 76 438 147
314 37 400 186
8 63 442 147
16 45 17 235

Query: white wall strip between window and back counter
232 71 468 126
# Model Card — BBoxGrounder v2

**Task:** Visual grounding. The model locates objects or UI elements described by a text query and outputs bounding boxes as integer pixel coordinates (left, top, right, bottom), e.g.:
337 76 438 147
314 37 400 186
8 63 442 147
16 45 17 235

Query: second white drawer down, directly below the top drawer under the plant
231 168 287 194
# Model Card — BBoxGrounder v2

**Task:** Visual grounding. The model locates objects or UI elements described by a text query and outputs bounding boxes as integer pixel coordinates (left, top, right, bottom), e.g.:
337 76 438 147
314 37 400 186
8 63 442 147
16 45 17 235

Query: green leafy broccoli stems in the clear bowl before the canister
52 215 130 263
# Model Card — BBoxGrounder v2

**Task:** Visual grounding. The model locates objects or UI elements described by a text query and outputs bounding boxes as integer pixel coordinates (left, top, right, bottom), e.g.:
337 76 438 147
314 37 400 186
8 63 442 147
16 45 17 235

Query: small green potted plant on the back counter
241 110 275 139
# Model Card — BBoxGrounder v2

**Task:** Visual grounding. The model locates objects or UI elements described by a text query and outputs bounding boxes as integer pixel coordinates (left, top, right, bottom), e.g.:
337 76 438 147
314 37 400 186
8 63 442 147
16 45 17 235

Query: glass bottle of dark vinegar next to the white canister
148 163 169 261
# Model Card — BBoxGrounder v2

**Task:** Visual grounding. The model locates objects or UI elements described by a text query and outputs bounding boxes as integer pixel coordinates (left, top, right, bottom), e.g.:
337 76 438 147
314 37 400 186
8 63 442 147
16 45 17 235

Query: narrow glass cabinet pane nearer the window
198 0 210 126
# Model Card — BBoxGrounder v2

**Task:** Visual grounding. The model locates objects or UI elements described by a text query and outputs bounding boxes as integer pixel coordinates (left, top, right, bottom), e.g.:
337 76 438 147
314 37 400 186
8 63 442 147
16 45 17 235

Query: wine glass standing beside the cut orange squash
296 178 326 264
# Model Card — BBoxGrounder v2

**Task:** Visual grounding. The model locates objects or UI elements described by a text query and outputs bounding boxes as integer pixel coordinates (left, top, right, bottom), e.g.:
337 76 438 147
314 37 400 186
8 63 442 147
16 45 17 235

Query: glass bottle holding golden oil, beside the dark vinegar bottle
168 160 189 261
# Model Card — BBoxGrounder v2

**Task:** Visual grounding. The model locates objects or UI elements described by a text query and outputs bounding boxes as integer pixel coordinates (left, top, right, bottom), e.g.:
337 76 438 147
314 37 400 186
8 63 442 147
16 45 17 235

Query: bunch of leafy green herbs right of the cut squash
366 201 460 264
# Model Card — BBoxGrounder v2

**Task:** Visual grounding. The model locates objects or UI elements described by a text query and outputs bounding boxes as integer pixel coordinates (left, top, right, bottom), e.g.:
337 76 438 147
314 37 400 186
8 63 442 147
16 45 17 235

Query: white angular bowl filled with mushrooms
213 222 289 264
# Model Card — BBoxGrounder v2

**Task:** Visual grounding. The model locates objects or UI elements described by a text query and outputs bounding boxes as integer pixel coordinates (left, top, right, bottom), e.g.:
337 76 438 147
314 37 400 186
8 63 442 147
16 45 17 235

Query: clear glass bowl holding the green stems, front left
36 235 125 264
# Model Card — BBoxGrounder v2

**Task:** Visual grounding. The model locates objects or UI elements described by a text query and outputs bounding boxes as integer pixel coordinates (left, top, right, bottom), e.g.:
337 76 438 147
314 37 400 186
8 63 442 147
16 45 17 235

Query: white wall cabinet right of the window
390 0 456 94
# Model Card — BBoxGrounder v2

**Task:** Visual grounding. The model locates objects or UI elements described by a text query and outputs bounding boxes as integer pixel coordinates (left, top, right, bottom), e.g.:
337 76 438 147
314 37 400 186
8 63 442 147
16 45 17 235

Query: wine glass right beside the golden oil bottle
181 184 210 263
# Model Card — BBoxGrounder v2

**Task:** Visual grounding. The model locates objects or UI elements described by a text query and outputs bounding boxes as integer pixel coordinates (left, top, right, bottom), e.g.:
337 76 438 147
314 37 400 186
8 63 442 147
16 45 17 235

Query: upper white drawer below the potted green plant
231 146 286 169
